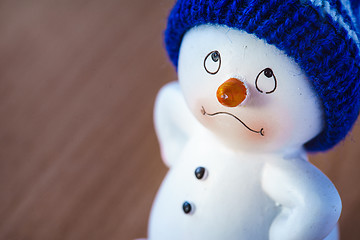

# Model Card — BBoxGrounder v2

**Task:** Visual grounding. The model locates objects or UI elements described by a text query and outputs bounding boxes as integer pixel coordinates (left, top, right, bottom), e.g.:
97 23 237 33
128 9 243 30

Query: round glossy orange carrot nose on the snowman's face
216 78 247 107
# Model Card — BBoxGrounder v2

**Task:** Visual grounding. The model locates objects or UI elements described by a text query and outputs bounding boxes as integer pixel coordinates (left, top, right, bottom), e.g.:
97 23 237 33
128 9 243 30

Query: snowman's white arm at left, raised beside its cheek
154 82 199 167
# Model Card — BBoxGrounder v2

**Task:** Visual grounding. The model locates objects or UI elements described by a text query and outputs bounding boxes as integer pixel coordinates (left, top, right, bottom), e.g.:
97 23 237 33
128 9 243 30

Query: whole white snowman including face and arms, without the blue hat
148 25 341 240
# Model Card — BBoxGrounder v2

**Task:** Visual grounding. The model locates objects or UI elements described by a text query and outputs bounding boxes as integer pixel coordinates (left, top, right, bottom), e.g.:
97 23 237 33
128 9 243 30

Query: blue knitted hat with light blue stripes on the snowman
165 0 360 152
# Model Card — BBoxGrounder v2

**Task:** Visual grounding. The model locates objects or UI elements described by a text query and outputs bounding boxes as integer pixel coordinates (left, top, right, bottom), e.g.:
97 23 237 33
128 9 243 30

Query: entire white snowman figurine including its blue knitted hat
148 0 360 240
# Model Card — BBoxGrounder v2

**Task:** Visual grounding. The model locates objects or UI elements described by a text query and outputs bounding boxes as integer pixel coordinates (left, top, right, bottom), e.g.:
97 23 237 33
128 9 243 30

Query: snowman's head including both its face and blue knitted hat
165 0 360 151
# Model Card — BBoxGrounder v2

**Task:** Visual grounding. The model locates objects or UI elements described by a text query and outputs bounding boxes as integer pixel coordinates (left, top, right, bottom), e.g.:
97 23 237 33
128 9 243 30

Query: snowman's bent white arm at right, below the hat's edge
262 159 341 240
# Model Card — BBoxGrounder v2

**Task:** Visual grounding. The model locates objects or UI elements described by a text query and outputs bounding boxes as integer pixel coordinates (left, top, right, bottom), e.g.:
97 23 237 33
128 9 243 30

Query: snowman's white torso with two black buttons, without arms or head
150 125 278 240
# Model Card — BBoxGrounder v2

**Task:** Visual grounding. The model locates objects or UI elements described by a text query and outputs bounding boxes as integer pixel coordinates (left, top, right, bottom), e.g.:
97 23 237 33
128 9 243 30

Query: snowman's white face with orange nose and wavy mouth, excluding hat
178 25 322 152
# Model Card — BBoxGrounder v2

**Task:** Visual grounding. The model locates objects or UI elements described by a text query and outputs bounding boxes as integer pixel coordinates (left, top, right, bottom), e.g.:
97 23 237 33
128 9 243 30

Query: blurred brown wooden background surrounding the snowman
0 0 360 240
